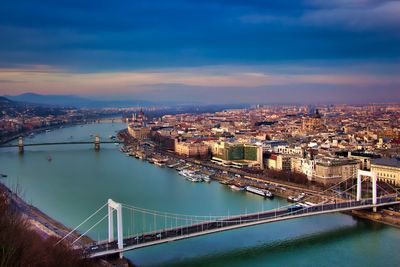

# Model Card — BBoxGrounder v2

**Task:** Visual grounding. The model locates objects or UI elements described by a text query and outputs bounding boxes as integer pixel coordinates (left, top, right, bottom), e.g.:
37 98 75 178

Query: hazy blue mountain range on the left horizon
6 93 154 108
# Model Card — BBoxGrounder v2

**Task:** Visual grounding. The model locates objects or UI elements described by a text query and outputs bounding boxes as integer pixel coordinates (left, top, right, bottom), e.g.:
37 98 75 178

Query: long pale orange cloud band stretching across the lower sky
0 65 400 95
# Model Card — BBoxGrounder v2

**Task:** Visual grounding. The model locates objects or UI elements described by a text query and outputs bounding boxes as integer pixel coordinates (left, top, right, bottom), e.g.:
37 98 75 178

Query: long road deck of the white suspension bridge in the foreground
86 197 400 258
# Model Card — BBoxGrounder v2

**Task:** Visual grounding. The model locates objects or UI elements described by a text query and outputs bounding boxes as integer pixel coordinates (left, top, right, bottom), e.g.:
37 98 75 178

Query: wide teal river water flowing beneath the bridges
0 123 400 266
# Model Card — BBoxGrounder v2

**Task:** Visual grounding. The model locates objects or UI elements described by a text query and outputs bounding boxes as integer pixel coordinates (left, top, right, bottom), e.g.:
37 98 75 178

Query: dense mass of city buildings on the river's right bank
122 105 400 184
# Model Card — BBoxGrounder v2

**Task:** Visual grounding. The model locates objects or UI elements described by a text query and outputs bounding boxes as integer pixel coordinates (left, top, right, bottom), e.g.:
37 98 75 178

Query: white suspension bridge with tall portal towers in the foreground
57 170 400 258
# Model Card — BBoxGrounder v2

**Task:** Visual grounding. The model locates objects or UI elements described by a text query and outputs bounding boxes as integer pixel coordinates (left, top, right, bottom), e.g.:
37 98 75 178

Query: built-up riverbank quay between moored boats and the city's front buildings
118 130 400 228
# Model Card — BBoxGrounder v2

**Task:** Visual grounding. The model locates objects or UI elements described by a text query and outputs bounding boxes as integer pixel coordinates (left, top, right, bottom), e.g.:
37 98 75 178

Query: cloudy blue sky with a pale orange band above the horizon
0 0 400 103
